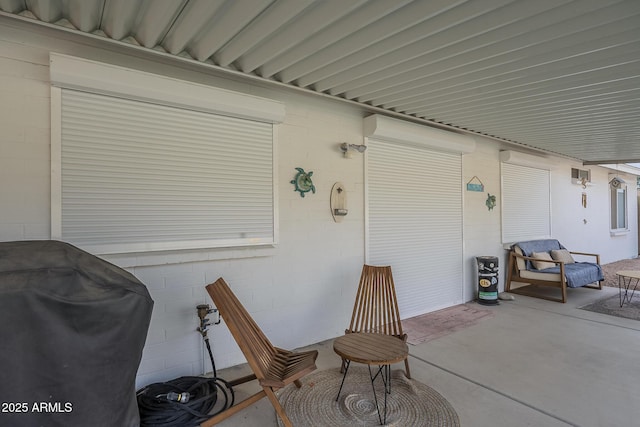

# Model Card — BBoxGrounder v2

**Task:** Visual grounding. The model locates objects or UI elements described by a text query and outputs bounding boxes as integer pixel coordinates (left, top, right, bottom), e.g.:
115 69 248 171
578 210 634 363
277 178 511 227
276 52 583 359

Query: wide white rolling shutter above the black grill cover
61 89 275 253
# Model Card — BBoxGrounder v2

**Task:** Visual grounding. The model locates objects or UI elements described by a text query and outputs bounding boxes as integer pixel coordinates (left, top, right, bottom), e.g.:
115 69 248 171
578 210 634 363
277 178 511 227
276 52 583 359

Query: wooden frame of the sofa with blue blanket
505 249 602 303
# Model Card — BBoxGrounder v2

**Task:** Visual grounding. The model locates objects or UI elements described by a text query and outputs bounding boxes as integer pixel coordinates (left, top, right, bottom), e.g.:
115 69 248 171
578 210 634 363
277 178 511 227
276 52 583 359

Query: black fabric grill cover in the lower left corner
0 241 153 427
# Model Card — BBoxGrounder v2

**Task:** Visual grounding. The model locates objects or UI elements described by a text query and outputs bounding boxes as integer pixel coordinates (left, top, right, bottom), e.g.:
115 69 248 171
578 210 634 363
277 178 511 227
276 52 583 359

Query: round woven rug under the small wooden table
277 365 460 427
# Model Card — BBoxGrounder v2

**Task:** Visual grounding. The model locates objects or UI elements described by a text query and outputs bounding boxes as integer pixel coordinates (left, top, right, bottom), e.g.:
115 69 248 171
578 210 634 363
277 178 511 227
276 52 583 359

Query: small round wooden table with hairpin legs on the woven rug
333 332 409 424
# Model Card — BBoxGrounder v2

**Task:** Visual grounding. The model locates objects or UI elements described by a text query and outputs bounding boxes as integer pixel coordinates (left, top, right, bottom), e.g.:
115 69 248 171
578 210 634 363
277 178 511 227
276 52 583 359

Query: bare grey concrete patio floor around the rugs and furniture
214 288 640 427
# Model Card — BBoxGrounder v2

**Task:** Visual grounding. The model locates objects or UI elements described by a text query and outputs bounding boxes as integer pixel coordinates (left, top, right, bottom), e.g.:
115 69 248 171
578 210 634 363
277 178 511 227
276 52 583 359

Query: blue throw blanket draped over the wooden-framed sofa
516 239 604 288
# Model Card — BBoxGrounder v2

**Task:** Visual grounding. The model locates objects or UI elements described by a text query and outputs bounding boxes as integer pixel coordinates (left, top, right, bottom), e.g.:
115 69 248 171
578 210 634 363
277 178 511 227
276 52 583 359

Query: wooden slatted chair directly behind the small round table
342 264 411 378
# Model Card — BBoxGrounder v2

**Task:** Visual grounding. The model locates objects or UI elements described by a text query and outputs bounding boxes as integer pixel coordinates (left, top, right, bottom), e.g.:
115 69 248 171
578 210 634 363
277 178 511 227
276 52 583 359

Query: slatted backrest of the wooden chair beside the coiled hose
207 278 276 379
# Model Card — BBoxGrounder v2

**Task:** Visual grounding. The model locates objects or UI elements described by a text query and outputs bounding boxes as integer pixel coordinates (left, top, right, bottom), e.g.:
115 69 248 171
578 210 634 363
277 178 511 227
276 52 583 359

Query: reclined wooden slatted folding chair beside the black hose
201 277 318 427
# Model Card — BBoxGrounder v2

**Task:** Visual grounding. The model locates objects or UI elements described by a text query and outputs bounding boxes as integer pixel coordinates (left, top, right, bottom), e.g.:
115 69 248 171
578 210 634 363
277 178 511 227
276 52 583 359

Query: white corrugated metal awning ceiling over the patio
0 0 640 163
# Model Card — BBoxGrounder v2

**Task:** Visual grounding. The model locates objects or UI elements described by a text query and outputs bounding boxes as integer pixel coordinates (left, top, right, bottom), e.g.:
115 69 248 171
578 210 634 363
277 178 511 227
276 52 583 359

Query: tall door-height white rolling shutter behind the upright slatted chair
367 139 463 318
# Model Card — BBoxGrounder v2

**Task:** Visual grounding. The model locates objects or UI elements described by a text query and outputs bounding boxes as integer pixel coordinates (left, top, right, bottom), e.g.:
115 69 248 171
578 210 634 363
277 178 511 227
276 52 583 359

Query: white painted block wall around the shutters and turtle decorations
0 20 637 385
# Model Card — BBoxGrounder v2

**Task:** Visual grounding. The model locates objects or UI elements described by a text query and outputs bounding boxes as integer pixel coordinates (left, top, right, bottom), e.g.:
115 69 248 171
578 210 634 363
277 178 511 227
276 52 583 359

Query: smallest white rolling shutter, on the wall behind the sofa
501 162 551 243
